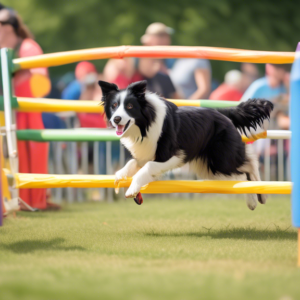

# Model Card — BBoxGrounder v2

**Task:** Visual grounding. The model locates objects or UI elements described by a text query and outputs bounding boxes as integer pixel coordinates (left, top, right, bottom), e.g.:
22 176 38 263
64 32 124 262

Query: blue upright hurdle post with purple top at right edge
290 42 300 267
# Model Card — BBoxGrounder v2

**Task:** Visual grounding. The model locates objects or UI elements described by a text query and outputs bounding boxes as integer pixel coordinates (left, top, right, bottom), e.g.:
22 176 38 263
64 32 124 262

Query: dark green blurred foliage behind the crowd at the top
2 0 300 79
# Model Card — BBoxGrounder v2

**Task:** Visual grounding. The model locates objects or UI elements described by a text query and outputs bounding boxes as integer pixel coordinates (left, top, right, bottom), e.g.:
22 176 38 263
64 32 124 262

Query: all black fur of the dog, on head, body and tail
99 81 273 176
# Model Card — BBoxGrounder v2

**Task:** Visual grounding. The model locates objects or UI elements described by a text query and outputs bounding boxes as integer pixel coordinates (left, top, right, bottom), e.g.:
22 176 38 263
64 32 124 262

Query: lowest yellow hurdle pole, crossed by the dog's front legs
15 173 292 194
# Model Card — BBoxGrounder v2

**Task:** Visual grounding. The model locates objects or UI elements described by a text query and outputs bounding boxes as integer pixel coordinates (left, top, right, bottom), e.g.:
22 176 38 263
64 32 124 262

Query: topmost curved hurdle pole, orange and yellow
13 46 295 70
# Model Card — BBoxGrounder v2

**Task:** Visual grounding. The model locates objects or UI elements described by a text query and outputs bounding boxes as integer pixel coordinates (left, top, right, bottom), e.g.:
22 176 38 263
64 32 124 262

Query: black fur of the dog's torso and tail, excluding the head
155 99 273 176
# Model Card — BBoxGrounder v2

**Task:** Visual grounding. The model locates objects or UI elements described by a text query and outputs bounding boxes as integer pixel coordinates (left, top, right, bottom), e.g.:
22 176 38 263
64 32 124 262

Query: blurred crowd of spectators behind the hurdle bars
0 6 291 209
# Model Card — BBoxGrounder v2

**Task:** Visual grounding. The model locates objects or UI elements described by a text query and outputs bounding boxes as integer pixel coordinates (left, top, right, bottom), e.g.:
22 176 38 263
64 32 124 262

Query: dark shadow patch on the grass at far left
0 238 85 254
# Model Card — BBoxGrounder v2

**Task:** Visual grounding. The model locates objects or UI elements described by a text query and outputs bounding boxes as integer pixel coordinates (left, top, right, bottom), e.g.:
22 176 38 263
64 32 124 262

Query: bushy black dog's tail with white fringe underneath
218 99 274 136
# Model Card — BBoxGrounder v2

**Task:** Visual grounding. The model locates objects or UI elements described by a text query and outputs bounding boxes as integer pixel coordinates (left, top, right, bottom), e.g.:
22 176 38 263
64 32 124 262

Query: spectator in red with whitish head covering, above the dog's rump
209 70 243 101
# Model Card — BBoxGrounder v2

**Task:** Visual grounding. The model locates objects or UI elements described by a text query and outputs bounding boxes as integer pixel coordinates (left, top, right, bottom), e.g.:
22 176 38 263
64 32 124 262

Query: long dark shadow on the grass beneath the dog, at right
144 225 297 240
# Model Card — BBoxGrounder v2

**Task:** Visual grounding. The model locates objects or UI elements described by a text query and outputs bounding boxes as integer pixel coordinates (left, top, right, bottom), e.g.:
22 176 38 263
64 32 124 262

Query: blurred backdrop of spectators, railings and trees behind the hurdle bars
0 0 300 207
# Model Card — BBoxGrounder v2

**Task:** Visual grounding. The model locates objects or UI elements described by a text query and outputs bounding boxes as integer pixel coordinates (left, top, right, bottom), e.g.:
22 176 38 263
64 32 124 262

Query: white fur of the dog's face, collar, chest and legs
110 91 267 210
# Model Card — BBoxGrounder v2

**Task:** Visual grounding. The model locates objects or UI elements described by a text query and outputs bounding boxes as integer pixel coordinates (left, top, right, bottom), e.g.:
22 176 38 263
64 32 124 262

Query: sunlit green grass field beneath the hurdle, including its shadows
0 196 300 300
